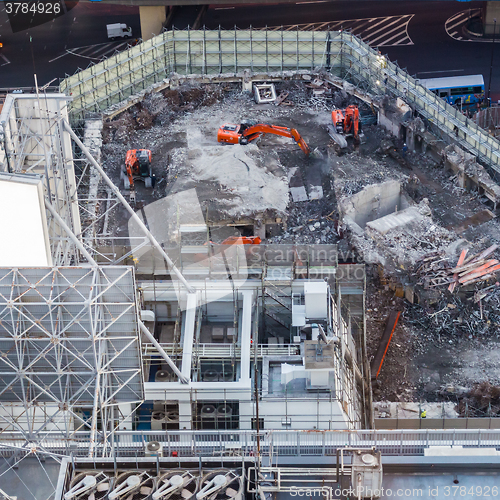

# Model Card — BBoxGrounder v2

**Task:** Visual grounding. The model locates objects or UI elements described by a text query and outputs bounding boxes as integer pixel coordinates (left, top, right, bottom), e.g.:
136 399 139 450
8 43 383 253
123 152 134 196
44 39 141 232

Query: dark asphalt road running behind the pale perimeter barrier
0 0 500 100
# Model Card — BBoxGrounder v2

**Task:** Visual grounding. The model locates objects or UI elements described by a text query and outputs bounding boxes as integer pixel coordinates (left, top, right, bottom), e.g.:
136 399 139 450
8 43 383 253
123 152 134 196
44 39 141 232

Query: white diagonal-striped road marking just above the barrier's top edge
267 14 415 47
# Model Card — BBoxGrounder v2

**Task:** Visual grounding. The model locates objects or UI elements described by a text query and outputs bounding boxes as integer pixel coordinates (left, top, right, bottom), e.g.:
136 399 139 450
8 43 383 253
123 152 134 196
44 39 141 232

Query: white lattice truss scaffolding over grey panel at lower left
0 266 144 456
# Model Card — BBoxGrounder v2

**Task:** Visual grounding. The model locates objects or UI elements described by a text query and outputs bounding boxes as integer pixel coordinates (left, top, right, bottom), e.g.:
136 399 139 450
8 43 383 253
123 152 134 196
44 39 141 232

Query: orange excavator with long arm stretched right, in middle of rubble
217 123 311 155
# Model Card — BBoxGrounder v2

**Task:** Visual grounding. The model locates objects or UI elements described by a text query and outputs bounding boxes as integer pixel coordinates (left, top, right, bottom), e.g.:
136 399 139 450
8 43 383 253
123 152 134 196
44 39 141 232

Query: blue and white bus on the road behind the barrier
419 75 484 106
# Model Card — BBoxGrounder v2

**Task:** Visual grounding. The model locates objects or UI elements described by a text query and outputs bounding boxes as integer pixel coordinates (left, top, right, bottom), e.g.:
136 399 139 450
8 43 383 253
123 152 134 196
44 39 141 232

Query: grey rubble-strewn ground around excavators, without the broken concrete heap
98 80 500 414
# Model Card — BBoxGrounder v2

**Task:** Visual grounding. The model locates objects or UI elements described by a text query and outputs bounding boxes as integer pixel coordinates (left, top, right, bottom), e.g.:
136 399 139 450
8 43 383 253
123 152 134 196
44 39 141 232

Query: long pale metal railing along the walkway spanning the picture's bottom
0 429 500 457
